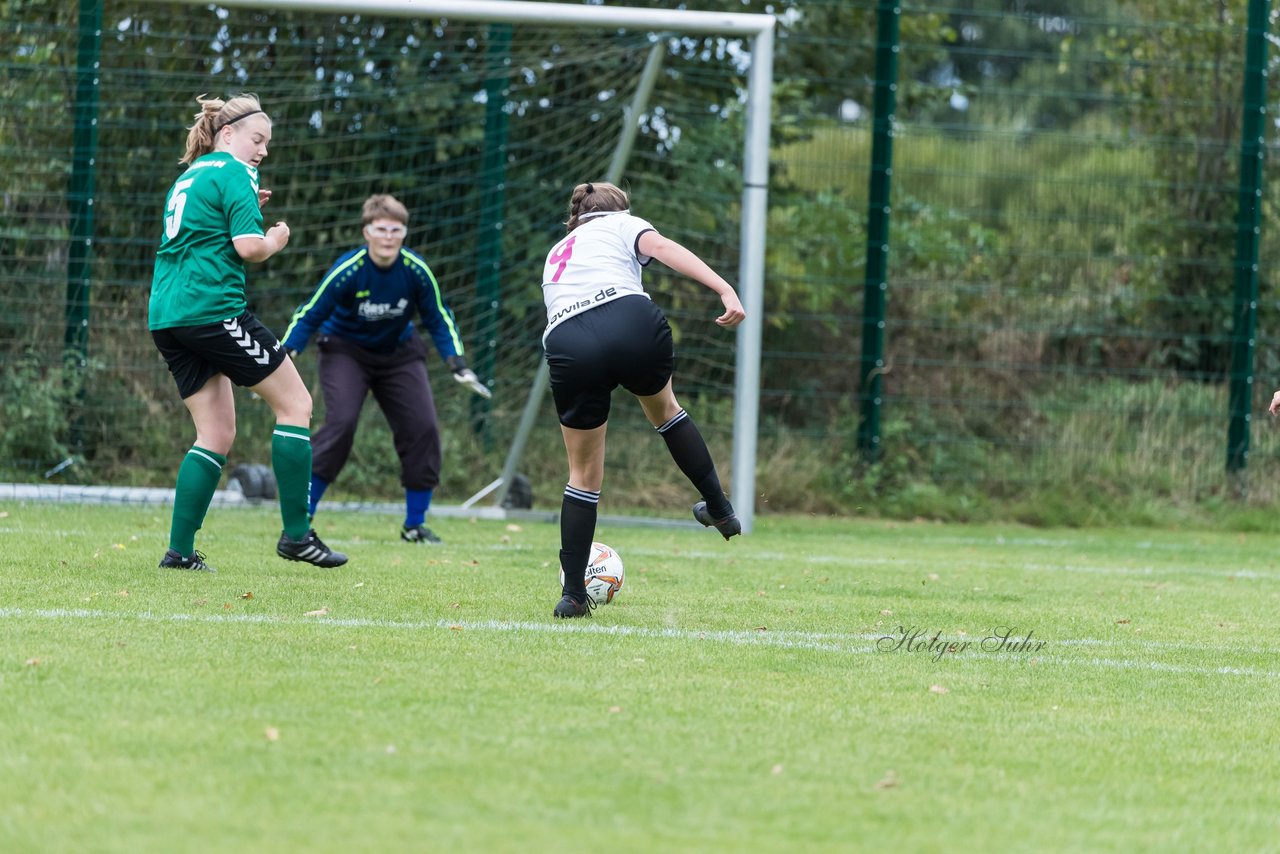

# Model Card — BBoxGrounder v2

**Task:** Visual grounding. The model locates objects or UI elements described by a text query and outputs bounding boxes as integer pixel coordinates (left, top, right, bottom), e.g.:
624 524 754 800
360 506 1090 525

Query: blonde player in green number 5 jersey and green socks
147 95 347 572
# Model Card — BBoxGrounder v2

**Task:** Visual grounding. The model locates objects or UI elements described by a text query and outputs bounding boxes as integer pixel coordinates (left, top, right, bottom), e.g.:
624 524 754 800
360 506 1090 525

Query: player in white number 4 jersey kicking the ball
543 182 746 617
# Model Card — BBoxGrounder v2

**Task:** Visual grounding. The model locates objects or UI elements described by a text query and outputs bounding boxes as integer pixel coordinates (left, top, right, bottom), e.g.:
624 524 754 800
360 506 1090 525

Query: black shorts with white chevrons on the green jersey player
151 311 287 399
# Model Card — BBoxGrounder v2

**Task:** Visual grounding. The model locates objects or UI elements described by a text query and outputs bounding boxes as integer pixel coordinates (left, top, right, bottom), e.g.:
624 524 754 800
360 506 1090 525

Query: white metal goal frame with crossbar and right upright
145 0 776 533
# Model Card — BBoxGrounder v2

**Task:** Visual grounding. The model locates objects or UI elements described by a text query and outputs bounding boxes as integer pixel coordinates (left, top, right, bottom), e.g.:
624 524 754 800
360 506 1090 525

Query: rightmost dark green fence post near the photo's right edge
1226 0 1271 483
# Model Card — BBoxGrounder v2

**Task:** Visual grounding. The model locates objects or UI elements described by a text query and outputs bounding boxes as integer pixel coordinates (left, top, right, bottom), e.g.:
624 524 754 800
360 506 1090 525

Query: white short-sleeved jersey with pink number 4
543 210 655 341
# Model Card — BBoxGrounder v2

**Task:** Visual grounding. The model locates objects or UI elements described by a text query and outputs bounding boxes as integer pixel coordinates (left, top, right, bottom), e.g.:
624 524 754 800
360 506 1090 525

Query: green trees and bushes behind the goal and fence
0 0 1280 522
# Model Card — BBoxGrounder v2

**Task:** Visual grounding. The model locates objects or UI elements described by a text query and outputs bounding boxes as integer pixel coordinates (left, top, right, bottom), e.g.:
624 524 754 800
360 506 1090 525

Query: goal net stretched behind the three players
0 0 772 527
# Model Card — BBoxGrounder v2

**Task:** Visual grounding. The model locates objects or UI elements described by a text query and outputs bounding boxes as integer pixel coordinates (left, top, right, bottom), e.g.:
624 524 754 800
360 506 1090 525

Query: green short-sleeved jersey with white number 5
148 151 264 329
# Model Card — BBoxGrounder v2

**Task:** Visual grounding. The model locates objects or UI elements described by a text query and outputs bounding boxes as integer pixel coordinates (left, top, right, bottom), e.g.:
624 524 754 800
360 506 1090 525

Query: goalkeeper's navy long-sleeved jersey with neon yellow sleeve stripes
283 246 463 360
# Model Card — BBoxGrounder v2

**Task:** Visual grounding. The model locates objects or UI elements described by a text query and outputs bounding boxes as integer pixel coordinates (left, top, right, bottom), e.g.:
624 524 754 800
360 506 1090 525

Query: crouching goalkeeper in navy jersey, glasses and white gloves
283 195 489 544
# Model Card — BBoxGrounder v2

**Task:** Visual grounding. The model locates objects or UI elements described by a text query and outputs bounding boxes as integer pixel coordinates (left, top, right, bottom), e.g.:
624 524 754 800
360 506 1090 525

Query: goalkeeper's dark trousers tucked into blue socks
311 335 440 490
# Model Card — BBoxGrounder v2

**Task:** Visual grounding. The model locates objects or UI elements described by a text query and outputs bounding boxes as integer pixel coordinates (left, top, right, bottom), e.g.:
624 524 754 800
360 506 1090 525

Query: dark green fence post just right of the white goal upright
858 0 902 462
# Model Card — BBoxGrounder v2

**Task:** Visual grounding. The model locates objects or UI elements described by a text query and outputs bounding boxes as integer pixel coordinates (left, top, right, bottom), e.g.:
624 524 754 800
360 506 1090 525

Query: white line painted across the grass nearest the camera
0 608 1280 679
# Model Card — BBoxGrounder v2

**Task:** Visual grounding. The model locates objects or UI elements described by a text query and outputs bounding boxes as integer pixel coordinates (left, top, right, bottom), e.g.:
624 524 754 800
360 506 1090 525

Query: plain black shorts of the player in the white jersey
547 294 676 430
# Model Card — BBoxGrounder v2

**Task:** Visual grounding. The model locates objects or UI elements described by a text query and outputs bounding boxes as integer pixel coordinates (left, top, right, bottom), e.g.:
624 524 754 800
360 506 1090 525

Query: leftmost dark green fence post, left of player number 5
63 0 102 451
